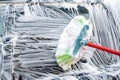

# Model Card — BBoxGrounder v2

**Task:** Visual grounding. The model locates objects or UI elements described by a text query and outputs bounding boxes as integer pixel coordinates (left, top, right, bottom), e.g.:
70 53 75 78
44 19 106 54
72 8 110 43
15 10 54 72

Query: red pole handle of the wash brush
86 42 120 56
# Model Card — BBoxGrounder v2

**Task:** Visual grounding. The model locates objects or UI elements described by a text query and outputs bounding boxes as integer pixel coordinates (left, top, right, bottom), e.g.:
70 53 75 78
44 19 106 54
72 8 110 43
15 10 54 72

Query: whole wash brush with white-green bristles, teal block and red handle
55 16 120 70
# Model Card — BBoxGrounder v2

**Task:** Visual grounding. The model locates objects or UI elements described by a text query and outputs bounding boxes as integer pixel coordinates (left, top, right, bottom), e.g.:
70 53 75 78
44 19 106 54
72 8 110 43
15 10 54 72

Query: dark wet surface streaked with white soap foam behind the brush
0 0 120 80
